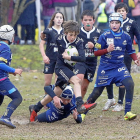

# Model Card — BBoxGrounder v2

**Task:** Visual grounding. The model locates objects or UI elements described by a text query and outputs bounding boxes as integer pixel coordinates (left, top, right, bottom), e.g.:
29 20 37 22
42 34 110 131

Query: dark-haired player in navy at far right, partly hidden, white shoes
104 2 140 111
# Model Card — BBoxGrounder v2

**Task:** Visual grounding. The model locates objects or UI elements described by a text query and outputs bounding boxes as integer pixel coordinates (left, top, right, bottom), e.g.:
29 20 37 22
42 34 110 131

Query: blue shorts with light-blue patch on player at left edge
0 78 17 95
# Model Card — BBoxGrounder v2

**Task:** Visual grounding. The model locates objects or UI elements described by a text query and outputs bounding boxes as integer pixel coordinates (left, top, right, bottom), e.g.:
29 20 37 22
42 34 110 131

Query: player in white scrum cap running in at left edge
0 25 22 128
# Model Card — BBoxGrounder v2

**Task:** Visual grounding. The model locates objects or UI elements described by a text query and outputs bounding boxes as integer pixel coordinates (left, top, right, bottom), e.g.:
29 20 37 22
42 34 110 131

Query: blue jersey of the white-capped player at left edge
0 41 12 79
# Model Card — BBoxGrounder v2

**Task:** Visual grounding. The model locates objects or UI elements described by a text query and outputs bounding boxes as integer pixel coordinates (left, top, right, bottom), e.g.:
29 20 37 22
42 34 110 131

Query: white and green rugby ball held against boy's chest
65 46 79 65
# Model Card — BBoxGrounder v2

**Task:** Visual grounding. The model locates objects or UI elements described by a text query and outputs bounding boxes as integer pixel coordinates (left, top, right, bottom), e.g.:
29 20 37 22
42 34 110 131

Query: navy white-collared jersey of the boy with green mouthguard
78 27 101 65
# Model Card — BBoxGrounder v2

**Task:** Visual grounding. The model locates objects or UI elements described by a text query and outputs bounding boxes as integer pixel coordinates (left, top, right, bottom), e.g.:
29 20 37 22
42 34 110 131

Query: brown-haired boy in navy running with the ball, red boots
31 21 95 117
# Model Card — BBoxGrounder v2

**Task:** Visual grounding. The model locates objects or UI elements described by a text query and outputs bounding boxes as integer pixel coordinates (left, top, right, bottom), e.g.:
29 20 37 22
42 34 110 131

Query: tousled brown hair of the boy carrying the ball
63 20 80 35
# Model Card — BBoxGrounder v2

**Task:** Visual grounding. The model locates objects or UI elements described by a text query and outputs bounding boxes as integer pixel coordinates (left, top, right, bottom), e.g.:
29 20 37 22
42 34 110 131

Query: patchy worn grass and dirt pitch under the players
0 46 140 140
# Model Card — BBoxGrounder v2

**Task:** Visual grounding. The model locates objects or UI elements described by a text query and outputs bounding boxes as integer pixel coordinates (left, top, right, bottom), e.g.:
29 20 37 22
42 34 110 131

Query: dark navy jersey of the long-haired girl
43 27 63 61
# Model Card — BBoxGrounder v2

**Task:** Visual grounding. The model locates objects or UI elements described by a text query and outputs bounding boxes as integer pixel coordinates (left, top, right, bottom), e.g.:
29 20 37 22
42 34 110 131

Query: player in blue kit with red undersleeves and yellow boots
84 13 140 120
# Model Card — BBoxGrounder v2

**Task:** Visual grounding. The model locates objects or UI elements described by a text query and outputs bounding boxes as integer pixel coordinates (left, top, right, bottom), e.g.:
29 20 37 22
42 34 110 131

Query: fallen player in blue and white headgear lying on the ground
29 85 96 123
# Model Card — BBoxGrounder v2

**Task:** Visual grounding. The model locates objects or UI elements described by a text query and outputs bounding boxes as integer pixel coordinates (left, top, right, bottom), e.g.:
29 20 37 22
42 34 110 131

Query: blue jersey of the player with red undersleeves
95 29 135 67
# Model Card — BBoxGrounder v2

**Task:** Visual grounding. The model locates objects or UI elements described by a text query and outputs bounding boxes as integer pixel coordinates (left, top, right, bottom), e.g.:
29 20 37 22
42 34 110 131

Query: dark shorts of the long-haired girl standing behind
43 60 56 74
